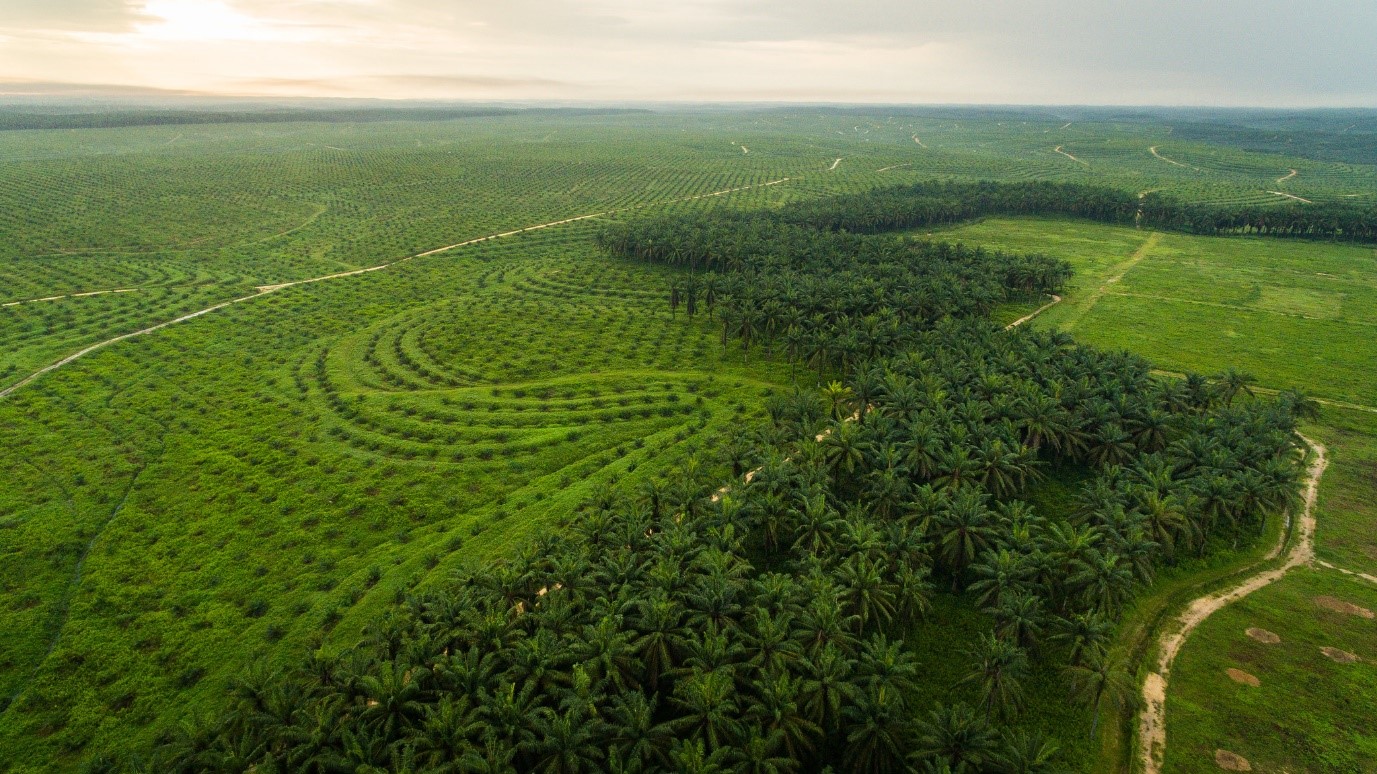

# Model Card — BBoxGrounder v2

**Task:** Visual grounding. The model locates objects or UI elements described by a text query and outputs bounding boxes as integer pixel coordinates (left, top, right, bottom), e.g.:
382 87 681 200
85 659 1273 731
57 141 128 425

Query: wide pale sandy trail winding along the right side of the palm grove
1137 437 1329 774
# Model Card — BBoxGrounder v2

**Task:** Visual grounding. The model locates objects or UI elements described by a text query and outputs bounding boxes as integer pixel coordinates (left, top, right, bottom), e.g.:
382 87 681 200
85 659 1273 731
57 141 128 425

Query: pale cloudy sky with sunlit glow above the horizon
0 0 1377 107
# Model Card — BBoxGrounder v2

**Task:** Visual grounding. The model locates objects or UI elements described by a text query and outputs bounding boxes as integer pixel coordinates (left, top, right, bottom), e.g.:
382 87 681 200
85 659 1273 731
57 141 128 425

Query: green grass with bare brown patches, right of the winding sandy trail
1164 567 1377 773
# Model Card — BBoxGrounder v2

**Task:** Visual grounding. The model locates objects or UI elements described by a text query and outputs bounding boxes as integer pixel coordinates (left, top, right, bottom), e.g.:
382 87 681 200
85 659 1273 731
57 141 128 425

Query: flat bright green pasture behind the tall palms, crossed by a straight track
935 219 1377 405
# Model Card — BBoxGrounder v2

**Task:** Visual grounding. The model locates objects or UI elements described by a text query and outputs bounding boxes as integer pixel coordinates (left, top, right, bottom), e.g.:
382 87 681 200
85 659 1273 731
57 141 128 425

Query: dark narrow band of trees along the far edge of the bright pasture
774 180 1377 242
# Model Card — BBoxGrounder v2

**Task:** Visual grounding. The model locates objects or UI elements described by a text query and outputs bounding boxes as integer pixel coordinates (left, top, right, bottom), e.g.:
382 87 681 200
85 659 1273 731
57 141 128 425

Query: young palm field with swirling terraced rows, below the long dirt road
0 223 798 766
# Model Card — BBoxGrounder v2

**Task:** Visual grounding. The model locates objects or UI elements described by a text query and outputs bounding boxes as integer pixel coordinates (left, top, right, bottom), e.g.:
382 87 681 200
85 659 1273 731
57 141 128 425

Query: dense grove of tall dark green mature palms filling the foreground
123 188 1310 773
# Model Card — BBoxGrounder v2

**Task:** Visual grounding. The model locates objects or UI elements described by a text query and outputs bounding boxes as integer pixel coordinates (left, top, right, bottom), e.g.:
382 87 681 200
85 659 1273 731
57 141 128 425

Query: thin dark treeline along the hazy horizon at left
0 107 646 131
